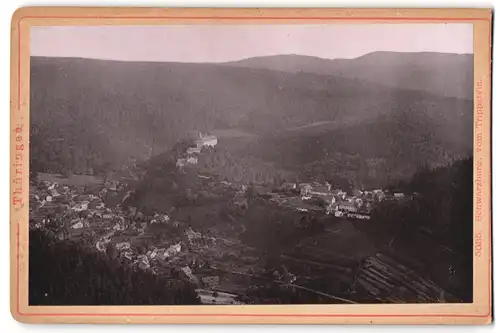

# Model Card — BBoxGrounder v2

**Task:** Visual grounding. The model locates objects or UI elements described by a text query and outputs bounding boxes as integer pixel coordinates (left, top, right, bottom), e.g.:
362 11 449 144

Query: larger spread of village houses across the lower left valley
30 172 238 288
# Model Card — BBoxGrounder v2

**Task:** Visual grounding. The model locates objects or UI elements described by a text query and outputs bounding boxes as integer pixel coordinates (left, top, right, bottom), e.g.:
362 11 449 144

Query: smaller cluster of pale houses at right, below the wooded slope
282 182 405 220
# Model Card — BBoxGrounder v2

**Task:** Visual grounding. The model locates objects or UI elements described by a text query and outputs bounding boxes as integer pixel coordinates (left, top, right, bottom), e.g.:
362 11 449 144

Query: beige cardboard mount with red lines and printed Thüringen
10 7 492 324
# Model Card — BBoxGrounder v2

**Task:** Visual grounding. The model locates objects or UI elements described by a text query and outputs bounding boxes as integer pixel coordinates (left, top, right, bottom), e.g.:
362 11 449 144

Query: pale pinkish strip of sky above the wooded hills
31 23 473 62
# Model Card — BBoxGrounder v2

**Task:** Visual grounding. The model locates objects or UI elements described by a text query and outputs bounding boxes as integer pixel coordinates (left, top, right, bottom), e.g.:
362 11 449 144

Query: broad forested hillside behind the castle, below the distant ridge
30 54 472 182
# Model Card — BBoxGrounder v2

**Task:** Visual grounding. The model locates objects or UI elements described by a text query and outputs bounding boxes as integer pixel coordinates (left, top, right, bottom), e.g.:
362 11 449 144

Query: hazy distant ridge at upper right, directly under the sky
226 51 474 100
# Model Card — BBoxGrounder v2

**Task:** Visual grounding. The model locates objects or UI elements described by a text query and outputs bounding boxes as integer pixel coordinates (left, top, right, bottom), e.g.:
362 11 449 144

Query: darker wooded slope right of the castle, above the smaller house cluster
244 99 473 188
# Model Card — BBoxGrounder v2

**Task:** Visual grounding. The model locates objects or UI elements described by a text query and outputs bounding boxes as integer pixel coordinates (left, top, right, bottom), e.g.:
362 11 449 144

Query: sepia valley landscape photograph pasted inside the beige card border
13 6 489 324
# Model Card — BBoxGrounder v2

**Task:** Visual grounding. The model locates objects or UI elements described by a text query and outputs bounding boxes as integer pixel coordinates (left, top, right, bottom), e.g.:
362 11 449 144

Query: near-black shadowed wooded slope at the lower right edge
365 158 473 302
